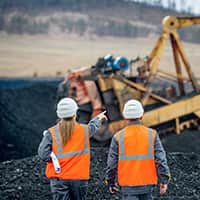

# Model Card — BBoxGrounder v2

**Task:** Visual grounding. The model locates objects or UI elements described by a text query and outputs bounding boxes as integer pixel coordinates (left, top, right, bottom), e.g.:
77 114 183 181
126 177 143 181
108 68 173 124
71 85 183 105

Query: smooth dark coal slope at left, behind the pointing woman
0 79 60 161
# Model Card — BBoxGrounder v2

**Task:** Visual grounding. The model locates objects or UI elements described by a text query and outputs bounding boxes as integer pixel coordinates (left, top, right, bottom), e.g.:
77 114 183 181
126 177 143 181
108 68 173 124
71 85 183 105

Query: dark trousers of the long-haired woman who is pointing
50 178 88 200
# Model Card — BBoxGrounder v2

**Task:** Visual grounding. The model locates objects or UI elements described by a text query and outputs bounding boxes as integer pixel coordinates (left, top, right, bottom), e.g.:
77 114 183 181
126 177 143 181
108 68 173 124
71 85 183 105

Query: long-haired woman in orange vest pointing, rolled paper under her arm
38 98 106 200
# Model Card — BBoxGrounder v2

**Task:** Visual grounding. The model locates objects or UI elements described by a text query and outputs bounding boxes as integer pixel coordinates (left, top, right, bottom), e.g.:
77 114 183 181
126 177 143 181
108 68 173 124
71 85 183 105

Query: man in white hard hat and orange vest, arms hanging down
106 99 170 200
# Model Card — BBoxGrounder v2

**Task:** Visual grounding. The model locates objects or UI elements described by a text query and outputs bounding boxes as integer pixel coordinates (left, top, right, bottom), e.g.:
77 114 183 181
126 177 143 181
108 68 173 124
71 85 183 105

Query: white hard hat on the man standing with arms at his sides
122 99 144 119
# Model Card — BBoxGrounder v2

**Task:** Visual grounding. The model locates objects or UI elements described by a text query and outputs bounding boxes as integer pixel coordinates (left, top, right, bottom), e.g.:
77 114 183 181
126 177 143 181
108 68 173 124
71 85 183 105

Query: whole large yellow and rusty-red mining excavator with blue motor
56 16 200 140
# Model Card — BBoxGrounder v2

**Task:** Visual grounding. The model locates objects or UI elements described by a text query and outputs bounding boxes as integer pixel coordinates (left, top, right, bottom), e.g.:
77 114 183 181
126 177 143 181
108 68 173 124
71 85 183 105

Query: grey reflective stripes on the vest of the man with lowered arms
119 128 154 160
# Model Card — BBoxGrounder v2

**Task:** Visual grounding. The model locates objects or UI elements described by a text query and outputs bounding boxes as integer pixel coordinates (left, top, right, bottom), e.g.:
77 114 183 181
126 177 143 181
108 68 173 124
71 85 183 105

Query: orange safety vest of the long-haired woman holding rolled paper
46 123 90 180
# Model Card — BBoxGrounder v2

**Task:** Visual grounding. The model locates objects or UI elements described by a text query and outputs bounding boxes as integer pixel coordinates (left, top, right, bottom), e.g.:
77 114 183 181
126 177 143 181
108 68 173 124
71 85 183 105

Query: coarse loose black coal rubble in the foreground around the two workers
0 148 200 200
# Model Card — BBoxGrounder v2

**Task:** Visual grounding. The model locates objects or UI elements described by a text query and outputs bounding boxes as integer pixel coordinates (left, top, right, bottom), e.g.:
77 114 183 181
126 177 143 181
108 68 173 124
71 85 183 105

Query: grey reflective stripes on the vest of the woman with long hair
54 125 90 158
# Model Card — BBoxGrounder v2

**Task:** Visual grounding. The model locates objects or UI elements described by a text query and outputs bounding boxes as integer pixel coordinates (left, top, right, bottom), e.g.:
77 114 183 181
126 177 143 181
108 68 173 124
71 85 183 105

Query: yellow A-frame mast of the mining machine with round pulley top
142 16 200 105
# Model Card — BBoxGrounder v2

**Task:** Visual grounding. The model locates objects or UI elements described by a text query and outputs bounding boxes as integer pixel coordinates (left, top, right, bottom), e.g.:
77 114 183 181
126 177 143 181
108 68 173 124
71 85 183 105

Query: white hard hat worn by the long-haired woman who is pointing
56 98 78 119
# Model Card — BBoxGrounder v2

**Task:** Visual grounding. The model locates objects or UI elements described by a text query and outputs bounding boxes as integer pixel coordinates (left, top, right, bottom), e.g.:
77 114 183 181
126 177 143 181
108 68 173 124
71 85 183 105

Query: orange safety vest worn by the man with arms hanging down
115 125 157 186
